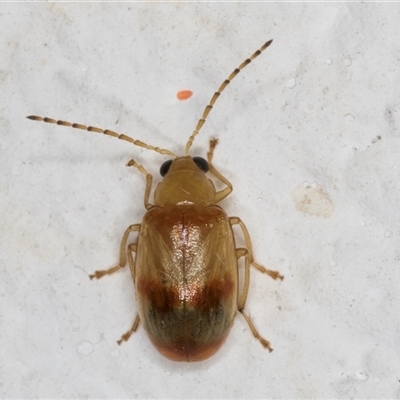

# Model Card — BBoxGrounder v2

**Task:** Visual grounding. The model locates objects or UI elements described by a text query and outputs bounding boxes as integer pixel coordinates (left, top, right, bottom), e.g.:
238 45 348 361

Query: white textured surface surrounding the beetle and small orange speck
0 2 400 398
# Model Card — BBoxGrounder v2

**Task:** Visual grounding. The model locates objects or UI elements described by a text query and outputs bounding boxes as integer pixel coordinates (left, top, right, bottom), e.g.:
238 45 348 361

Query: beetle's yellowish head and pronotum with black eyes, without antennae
154 156 215 205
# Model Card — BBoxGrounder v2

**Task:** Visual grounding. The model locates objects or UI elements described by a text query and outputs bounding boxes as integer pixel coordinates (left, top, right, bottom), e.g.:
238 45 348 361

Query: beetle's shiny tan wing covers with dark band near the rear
134 205 238 361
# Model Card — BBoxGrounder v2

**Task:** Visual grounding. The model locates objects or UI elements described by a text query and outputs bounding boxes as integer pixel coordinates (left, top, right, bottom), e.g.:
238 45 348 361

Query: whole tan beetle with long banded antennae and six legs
27 40 283 361
